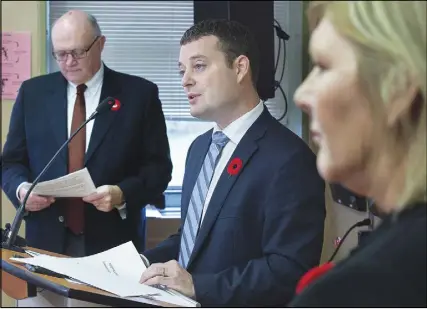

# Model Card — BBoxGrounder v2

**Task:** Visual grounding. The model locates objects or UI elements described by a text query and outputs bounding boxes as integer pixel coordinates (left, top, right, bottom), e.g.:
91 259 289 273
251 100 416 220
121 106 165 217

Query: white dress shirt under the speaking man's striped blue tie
200 101 264 226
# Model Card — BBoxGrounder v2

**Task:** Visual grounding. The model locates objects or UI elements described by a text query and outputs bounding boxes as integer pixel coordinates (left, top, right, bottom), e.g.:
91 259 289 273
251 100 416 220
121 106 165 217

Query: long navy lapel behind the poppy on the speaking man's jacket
187 106 270 267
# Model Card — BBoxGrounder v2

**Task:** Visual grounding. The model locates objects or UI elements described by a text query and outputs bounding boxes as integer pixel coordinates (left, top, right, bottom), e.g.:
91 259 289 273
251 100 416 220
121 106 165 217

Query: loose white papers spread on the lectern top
11 241 199 307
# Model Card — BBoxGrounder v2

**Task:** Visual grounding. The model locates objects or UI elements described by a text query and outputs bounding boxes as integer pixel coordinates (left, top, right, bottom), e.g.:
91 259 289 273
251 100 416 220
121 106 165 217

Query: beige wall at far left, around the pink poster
1 1 46 307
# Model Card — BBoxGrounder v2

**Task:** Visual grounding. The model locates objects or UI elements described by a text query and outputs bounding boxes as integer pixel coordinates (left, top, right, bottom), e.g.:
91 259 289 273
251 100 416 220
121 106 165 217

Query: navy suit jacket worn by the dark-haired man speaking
145 107 325 307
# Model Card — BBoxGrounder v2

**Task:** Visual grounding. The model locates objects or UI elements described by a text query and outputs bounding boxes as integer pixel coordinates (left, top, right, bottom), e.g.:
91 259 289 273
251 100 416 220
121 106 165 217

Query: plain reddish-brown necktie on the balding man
65 84 87 235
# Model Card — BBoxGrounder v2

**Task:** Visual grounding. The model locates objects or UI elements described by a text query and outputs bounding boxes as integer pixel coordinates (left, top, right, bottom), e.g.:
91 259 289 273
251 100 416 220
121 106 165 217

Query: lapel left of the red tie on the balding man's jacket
46 73 68 163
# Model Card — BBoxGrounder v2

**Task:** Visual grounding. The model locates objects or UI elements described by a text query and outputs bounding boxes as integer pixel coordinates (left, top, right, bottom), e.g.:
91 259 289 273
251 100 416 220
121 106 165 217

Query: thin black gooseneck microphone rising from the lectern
1 97 121 253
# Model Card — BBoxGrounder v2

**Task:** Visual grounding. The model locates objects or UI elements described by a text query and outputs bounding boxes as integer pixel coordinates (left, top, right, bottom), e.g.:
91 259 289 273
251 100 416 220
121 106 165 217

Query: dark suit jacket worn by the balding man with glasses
2 66 172 254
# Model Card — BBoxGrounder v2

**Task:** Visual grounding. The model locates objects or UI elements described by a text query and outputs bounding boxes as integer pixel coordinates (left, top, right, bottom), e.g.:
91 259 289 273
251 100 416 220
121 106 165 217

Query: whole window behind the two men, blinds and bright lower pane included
47 1 294 212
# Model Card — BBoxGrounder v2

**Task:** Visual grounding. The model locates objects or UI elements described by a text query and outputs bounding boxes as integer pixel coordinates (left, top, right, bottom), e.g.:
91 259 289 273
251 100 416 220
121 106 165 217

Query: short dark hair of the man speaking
180 19 259 88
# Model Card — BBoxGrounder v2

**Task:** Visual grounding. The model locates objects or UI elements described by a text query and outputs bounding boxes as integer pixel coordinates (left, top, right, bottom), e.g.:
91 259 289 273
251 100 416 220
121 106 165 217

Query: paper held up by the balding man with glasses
22 168 96 197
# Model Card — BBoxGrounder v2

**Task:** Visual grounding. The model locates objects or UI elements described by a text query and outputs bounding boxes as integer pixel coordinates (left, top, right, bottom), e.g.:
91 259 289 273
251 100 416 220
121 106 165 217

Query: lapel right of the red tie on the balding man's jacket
85 65 120 165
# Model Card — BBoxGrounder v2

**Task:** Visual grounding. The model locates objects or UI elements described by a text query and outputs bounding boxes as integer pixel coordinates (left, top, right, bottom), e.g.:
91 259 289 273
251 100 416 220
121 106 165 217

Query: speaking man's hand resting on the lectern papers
139 260 196 299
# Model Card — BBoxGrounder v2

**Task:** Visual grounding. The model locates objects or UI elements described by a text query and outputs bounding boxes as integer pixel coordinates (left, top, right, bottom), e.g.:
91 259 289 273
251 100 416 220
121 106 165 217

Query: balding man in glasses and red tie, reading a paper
2 11 172 256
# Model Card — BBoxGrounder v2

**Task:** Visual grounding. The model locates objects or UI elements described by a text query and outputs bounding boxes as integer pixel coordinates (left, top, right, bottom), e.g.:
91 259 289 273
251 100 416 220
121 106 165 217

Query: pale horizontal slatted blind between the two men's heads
49 1 193 120
